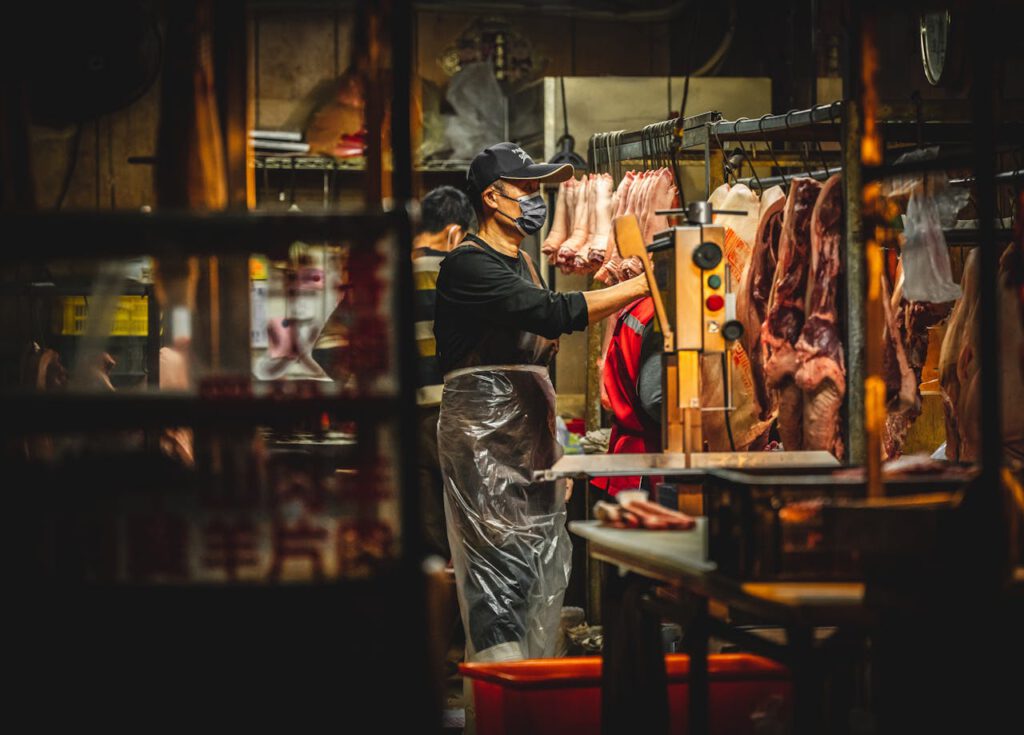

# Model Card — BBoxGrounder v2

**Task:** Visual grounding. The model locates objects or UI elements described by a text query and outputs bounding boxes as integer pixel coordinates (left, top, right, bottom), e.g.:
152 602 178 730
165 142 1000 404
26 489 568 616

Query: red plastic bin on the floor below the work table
460 653 792 735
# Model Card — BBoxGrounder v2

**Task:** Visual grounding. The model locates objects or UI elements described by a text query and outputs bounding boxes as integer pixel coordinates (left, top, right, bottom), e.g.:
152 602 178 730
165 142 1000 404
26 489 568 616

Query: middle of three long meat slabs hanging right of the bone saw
761 178 821 450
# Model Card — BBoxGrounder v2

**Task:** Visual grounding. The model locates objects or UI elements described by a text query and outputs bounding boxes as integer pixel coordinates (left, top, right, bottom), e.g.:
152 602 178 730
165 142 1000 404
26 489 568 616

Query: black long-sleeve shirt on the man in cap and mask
434 235 588 373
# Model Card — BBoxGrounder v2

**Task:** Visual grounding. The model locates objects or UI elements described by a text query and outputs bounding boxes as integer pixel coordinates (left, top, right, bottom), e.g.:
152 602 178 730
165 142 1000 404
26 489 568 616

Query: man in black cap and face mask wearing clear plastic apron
434 142 648 661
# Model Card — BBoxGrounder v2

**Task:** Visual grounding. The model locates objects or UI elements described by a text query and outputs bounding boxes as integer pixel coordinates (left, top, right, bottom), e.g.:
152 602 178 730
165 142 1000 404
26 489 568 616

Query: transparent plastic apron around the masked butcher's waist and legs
437 244 572 661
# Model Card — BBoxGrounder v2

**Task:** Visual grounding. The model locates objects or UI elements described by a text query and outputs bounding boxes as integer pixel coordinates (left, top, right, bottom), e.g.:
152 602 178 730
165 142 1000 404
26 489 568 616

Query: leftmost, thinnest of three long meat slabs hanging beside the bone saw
736 186 785 421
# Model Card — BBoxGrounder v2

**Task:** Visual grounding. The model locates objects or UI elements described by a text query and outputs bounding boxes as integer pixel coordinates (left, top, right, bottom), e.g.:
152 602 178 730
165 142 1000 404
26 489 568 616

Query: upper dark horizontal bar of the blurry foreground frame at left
0 210 406 261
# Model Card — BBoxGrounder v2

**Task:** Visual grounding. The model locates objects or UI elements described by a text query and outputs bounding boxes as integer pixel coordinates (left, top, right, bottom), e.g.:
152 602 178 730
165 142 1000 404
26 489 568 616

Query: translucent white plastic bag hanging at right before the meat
902 183 968 303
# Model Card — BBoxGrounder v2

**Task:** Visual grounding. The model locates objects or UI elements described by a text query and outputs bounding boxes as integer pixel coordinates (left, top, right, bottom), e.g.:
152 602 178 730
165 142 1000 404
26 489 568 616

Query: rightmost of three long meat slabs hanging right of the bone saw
795 174 846 459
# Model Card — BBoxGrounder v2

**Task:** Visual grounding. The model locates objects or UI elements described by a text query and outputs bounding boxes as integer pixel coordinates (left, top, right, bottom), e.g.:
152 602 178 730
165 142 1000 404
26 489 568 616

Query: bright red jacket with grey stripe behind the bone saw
593 297 662 495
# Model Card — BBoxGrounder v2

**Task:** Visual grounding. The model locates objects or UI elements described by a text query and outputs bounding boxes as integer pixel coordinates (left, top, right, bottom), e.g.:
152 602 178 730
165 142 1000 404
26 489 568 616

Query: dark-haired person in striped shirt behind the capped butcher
413 186 476 560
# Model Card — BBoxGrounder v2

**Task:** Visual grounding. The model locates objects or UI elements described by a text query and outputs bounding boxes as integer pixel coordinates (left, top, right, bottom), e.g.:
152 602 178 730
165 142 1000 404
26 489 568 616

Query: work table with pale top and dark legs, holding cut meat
569 518 871 733
